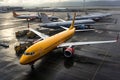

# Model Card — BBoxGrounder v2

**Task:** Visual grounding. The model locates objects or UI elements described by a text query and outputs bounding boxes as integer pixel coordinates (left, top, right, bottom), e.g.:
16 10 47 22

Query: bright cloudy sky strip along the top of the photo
0 0 118 6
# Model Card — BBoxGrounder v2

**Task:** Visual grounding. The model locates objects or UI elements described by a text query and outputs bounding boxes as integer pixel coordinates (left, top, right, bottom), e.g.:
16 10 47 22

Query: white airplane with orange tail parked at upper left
13 11 58 21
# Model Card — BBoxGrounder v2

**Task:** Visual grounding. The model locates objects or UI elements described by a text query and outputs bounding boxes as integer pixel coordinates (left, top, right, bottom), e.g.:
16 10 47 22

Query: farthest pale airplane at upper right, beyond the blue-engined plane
67 13 112 21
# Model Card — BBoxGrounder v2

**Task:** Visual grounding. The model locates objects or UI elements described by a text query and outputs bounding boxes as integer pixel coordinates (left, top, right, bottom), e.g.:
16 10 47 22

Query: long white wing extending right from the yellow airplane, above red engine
58 40 117 48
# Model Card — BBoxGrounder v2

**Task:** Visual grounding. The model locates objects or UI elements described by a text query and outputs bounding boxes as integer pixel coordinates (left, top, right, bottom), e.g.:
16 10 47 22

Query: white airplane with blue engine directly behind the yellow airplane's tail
39 13 95 30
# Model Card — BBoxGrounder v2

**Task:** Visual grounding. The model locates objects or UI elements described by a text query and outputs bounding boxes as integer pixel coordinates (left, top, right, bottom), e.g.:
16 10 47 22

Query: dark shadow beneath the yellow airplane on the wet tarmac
20 50 102 80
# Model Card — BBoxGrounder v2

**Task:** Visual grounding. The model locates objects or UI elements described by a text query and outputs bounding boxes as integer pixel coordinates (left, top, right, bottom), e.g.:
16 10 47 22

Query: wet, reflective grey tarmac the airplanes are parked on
0 11 120 80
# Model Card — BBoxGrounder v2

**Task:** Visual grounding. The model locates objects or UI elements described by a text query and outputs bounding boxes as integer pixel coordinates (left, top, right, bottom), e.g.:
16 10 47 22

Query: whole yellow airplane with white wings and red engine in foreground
20 14 117 69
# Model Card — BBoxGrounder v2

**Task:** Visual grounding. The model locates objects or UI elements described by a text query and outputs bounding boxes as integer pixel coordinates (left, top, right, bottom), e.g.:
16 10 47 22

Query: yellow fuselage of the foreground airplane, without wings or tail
20 28 75 65
